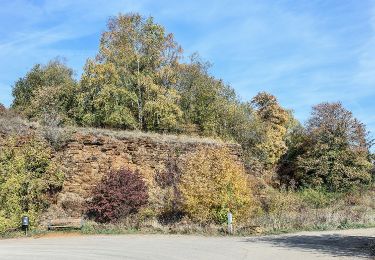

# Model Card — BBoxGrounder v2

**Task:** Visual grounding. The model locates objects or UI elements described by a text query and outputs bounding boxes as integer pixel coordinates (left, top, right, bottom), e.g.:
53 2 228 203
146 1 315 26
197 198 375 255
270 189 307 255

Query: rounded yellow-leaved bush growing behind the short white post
179 148 254 223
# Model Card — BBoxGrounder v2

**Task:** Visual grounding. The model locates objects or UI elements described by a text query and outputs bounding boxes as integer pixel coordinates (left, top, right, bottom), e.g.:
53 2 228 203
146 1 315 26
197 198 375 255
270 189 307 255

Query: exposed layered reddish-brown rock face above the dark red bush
54 130 241 216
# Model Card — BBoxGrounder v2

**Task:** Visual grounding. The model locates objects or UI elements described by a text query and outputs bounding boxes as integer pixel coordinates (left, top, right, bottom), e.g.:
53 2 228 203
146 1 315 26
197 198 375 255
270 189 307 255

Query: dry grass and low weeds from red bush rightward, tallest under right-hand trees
84 190 375 237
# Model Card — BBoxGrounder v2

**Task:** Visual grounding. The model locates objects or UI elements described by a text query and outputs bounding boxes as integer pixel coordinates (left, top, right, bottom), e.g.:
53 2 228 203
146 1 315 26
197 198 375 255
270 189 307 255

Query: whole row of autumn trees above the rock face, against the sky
12 14 374 190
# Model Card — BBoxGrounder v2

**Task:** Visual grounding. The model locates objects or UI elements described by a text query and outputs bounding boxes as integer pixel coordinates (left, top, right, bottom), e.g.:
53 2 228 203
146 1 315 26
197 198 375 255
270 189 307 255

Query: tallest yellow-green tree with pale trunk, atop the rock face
77 14 182 131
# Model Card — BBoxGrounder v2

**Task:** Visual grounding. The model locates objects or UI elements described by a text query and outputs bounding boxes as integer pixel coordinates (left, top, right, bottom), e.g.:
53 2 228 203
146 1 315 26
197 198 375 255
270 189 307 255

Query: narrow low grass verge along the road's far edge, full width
0 213 375 240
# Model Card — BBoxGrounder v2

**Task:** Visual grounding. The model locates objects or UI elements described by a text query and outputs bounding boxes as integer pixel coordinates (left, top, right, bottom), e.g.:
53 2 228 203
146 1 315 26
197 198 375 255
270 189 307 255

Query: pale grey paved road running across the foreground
0 229 375 260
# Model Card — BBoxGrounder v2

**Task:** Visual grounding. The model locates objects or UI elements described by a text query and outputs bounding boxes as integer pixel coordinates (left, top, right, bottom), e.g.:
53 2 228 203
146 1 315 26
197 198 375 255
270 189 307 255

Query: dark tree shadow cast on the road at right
246 235 375 259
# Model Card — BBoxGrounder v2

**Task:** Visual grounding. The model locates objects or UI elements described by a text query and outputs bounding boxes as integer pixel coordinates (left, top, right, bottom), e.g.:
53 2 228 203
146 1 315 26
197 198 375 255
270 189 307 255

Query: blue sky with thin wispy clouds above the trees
0 0 375 136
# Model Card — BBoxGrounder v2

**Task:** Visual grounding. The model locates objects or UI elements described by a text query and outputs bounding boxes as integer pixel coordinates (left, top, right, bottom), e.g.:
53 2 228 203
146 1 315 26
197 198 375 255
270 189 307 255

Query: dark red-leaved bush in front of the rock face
87 169 148 223
